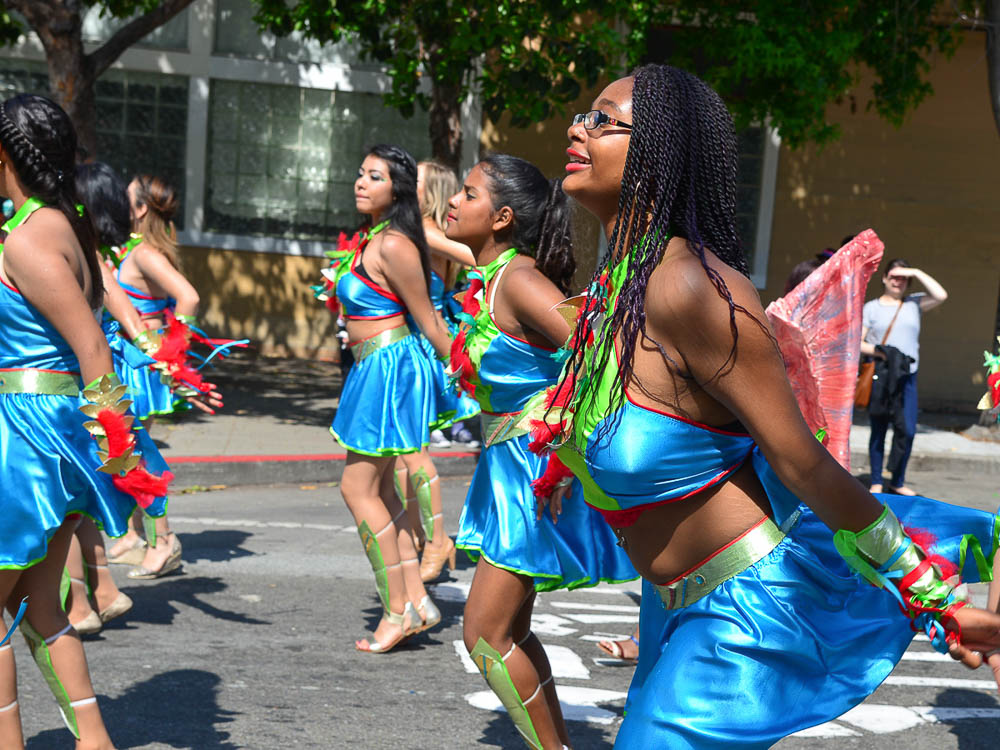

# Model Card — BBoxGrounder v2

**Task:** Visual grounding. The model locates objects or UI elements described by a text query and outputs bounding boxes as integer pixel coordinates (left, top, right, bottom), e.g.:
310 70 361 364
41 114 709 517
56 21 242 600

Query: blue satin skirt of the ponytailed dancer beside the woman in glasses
455 435 639 591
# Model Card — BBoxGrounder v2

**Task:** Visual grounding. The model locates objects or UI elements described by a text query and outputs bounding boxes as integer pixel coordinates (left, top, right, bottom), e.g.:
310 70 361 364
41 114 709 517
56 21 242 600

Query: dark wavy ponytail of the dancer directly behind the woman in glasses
479 154 576 294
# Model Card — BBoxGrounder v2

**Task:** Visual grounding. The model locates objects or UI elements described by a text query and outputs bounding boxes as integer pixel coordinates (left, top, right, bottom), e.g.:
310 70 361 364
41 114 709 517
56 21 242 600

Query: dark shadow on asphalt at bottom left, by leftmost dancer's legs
25 669 240 750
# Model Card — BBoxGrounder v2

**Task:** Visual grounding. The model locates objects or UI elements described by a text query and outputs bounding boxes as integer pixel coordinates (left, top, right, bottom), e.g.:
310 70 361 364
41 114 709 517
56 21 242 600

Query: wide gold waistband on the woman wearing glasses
655 518 785 609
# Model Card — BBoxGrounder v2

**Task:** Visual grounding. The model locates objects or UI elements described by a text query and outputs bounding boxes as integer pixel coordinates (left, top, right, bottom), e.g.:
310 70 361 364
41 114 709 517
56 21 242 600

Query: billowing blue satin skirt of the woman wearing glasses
615 462 998 750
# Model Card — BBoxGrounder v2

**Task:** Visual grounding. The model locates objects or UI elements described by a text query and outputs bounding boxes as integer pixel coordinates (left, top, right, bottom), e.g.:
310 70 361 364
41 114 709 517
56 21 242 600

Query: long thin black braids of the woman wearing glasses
566 65 766 440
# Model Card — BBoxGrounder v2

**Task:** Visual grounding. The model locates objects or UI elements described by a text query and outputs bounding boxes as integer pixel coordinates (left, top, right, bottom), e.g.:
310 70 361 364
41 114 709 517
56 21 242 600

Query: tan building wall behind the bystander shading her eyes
761 33 1000 411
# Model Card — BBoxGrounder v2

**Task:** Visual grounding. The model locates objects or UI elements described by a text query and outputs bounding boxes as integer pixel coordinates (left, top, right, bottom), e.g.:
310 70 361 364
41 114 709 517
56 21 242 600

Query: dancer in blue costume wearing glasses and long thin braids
538 66 1000 748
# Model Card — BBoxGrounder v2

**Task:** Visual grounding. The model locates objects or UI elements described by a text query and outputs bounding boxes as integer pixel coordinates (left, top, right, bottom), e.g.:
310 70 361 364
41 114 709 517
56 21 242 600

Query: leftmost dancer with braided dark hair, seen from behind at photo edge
0 95 164 750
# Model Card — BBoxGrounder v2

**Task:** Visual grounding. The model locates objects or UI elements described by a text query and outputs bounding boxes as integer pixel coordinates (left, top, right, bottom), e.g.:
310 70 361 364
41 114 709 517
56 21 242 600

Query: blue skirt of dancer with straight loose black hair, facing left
330 334 434 456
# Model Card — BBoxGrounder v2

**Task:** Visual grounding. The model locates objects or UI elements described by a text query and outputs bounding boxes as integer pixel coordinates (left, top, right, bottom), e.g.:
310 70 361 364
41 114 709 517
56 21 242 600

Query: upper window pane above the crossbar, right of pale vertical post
214 0 370 69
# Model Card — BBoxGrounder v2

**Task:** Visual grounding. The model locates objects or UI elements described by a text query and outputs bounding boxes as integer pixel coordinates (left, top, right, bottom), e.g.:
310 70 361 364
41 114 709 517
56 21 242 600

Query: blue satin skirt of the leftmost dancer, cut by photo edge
0 393 166 569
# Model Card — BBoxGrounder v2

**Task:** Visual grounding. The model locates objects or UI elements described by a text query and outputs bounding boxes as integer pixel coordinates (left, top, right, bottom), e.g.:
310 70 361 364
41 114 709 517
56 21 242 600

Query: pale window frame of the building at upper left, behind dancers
2 0 482 257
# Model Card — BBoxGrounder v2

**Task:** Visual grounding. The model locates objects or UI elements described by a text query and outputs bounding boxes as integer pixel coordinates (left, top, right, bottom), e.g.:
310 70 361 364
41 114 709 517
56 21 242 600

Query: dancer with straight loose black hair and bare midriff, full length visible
330 144 449 653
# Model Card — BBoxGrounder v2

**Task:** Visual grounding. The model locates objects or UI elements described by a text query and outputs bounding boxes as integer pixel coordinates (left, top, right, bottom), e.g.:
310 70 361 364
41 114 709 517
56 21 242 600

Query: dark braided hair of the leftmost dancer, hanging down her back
0 94 104 308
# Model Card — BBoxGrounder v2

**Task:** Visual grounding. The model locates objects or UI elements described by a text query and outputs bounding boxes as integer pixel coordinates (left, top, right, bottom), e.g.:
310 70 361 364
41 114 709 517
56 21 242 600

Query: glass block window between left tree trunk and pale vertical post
97 70 188 228
